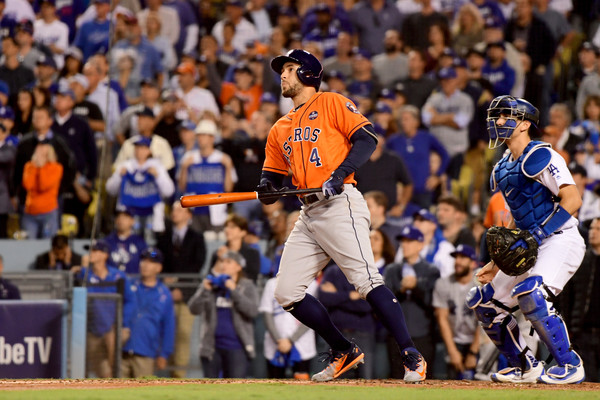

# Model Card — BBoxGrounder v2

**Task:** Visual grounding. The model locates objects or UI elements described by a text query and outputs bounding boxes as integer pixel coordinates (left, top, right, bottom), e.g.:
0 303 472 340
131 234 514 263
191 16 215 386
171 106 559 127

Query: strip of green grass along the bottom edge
0 383 600 400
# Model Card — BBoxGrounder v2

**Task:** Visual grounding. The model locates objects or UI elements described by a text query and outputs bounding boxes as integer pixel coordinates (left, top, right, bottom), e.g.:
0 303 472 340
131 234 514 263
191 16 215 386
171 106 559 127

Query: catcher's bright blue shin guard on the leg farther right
512 276 579 366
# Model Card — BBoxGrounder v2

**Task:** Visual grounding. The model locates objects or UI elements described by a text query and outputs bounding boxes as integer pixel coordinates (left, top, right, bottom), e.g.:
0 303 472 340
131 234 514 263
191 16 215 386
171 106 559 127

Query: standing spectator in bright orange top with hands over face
21 140 63 239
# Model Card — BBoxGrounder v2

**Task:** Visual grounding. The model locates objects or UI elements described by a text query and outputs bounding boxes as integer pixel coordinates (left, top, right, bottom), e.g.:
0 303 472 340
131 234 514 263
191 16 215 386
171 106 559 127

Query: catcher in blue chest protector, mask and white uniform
467 96 585 384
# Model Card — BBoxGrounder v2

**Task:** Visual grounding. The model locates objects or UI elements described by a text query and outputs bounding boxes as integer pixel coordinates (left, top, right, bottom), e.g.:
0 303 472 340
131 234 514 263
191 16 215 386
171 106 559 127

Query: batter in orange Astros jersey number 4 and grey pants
257 50 427 382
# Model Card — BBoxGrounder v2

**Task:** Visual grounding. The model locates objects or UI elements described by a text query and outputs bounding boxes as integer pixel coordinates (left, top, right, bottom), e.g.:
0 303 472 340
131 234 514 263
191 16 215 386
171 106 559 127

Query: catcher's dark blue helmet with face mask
487 96 540 149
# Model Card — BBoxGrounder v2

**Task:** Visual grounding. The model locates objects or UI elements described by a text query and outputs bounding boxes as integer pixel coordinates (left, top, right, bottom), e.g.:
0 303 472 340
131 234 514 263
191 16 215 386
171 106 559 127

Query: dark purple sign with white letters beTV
0 300 64 378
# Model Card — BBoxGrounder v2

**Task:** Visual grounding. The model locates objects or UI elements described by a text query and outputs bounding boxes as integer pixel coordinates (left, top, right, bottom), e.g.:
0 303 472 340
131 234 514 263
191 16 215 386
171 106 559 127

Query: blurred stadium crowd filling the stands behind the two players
0 0 600 381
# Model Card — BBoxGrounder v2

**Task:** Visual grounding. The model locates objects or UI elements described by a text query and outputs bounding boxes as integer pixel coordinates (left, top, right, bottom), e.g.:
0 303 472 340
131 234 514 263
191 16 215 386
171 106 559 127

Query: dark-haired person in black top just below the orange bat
209 214 260 283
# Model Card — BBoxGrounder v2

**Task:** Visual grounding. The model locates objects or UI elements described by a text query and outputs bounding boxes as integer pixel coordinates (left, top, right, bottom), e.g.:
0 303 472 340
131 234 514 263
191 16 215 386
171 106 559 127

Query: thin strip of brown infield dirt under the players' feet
0 379 600 397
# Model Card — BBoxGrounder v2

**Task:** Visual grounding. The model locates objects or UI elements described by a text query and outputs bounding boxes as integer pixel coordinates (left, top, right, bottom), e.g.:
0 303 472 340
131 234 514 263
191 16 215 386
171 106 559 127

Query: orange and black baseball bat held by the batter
179 188 321 208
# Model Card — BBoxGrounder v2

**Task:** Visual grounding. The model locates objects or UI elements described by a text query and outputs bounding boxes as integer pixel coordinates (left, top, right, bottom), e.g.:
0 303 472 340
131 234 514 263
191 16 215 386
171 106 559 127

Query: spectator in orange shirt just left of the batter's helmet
219 62 262 120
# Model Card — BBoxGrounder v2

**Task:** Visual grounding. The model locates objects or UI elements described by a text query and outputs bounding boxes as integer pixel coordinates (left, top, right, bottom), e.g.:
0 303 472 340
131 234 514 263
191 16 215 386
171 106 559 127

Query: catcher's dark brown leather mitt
485 226 539 276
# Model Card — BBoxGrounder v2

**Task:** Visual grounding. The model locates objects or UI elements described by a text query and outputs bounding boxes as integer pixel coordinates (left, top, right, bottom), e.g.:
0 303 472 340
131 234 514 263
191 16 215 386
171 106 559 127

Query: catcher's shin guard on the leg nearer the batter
466 283 529 370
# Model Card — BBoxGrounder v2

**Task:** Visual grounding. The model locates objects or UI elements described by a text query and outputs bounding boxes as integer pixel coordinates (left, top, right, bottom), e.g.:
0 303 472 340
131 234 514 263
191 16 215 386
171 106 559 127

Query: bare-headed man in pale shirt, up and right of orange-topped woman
83 58 119 142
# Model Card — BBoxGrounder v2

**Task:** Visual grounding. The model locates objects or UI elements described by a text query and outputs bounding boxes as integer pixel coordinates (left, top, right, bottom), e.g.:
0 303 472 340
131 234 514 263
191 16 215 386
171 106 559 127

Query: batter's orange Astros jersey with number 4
263 92 370 189
